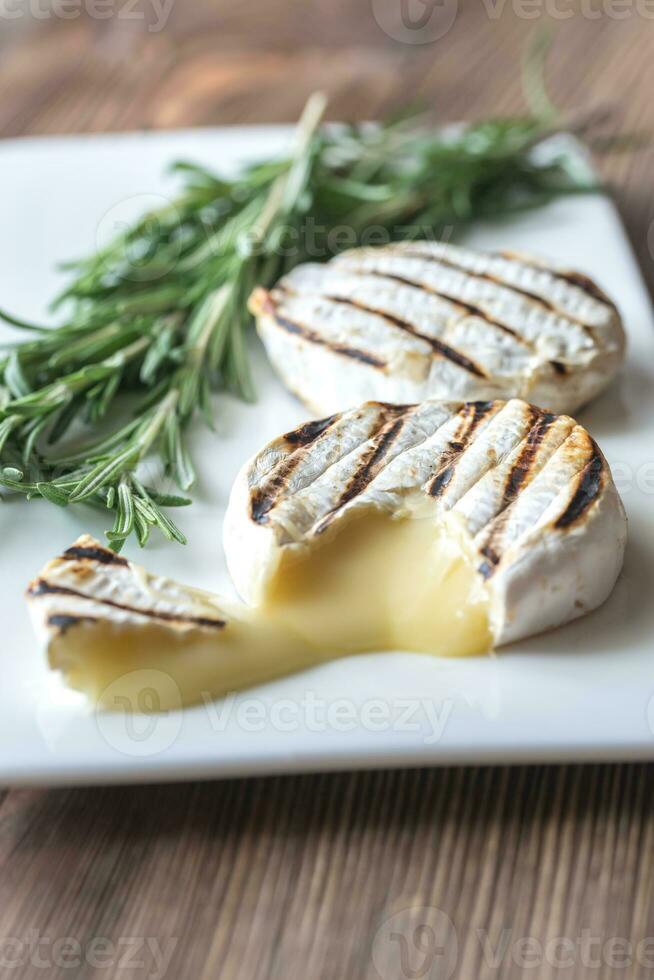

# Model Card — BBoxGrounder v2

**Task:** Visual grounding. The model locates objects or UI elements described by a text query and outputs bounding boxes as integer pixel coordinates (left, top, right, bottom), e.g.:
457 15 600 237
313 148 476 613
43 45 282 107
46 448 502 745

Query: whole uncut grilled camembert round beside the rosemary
250 242 625 415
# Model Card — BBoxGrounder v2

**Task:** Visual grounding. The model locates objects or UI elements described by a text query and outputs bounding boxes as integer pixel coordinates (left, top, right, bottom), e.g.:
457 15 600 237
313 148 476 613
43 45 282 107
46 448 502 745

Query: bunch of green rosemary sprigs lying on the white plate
0 70 628 549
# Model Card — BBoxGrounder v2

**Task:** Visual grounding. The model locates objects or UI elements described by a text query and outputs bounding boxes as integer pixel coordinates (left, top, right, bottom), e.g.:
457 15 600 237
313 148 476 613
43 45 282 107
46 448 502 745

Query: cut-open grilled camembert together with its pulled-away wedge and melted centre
28 400 626 710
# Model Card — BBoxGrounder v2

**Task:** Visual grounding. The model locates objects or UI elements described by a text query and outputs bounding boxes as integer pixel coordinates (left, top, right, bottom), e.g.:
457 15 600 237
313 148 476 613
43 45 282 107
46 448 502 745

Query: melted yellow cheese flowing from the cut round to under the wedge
44 509 492 711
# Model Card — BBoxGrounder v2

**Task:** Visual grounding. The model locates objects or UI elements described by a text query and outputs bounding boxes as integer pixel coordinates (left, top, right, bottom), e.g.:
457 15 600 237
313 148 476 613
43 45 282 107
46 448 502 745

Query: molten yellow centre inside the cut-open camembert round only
261 509 491 656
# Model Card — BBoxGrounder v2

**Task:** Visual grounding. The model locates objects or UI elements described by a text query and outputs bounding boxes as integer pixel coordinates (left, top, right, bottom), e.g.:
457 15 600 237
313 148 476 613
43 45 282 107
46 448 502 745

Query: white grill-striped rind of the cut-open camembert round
224 399 626 644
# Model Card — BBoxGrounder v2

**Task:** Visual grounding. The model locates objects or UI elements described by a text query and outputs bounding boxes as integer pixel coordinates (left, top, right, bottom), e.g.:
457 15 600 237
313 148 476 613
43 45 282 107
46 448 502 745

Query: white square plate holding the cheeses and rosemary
0 127 654 784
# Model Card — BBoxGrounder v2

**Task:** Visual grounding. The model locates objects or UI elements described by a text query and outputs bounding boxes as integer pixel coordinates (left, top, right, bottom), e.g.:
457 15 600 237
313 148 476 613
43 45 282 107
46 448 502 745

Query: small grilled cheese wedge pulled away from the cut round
27 535 324 711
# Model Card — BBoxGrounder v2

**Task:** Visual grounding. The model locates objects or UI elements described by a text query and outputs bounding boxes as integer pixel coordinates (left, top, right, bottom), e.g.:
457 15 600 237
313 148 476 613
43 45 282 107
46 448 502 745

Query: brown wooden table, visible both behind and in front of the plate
0 0 654 980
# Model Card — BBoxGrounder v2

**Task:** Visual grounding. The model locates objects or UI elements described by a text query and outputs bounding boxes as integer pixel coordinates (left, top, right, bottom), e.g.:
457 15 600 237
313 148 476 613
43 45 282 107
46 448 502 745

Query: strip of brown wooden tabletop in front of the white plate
0 766 654 980
